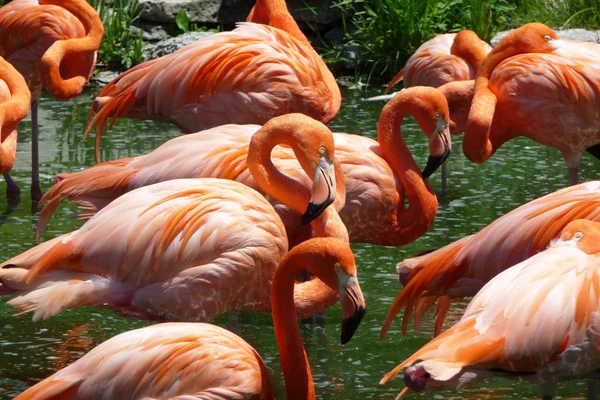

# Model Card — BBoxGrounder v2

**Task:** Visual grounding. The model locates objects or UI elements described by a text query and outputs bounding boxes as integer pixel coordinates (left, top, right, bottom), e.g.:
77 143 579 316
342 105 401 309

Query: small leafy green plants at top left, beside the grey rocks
88 0 143 70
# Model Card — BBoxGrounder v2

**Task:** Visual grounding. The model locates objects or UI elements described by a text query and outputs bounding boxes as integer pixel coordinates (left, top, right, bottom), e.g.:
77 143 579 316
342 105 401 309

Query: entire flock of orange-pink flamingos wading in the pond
0 0 600 400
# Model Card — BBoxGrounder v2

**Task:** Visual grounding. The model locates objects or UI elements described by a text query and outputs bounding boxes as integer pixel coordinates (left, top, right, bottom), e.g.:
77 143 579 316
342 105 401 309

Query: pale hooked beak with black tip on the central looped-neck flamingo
300 157 335 225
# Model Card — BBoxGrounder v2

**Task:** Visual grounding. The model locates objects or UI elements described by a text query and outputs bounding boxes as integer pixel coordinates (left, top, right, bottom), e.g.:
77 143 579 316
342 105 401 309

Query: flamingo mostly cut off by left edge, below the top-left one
0 57 31 198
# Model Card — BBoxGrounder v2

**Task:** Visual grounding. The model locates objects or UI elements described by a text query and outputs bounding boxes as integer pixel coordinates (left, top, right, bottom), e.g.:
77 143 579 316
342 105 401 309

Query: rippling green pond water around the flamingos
0 88 600 399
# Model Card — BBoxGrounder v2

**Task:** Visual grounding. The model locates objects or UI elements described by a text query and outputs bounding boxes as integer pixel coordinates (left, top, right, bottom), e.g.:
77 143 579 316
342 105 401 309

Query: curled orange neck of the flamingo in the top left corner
39 0 104 100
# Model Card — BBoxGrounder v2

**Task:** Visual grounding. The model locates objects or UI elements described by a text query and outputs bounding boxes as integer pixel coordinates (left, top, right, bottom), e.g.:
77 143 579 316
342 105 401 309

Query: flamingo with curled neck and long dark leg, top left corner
0 0 104 202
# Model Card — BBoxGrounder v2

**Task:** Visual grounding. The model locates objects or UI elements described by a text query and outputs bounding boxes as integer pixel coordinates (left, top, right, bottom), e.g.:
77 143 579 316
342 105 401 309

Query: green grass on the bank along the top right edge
326 0 600 78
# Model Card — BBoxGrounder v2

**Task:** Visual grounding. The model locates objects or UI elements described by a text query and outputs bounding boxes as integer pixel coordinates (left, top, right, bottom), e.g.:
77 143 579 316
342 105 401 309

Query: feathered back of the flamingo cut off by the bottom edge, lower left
16 323 273 400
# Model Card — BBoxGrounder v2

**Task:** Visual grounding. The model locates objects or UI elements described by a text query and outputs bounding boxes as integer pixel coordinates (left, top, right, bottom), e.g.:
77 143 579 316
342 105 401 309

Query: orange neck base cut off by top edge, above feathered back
246 0 310 46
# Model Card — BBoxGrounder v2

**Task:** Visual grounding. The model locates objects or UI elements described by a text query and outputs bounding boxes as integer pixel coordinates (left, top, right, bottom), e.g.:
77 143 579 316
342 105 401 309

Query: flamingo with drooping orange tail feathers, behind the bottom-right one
382 181 600 337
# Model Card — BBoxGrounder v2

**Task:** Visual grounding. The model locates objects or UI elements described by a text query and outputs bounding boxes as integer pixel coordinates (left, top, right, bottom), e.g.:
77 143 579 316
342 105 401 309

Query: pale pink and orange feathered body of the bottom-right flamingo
383 245 600 387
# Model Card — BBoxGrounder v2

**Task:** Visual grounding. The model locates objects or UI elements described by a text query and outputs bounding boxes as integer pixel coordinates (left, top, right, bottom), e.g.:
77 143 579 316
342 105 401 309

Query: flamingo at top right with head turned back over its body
463 24 600 185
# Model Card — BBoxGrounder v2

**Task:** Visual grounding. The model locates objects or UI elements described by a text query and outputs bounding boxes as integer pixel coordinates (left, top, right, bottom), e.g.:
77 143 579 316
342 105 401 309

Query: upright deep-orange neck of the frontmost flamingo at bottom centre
271 250 317 400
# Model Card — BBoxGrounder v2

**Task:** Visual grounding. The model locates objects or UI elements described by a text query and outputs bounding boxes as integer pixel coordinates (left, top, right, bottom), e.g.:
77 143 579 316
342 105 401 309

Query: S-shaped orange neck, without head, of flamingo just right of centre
377 96 438 245
